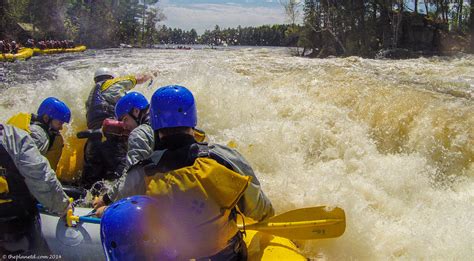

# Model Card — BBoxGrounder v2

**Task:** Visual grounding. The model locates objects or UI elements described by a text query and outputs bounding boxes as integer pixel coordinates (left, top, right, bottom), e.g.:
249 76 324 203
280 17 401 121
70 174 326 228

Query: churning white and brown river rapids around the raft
0 48 474 260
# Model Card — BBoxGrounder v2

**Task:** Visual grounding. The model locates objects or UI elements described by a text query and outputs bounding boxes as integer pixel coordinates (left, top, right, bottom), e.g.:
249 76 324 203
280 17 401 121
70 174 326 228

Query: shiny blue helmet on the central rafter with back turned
150 85 197 130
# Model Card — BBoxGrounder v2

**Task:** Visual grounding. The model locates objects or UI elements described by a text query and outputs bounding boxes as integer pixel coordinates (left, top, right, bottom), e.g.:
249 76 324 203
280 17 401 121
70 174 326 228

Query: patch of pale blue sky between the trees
159 0 287 34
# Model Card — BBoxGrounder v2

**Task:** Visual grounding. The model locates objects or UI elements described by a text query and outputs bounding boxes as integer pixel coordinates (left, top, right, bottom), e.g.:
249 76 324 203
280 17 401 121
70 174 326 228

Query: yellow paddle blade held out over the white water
239 206 346 239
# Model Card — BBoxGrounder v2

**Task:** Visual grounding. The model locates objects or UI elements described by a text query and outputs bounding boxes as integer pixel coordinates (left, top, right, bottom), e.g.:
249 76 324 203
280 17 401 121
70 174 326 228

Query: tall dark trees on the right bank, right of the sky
292 0 474 57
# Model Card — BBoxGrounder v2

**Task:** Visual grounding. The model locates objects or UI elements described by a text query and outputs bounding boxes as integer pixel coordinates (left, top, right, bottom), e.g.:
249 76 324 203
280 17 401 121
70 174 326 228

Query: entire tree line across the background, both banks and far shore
0 0 474 57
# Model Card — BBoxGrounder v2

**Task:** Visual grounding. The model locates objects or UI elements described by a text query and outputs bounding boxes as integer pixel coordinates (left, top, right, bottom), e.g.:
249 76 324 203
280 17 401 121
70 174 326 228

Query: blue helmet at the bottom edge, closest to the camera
100 196 167 260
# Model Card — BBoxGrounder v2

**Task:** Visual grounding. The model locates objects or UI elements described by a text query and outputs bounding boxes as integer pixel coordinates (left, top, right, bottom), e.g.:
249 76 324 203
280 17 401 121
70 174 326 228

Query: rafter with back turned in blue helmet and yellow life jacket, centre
93 85 274 260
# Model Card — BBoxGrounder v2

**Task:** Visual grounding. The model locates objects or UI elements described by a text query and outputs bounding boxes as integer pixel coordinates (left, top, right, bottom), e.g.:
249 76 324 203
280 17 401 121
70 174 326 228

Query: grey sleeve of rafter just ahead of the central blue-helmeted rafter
124 124 155 172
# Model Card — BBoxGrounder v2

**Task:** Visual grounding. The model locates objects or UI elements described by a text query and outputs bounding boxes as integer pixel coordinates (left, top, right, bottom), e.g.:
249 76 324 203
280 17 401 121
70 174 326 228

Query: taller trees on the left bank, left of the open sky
0 0 165 48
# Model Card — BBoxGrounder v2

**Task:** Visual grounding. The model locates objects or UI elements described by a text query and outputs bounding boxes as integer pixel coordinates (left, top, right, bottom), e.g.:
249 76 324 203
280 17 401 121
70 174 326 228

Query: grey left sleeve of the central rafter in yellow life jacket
107 166 146 202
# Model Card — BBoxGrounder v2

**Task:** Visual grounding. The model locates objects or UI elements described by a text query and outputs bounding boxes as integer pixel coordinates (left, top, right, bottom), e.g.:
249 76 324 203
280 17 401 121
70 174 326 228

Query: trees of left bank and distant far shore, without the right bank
0 0 298 48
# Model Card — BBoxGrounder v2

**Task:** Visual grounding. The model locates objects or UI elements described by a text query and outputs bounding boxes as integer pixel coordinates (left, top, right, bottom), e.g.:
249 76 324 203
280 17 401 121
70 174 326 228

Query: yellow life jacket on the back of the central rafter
145 157 250 259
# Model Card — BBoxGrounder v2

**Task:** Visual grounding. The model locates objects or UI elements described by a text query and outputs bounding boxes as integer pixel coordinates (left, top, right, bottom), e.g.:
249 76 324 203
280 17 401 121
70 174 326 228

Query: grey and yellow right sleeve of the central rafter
210 144 275 221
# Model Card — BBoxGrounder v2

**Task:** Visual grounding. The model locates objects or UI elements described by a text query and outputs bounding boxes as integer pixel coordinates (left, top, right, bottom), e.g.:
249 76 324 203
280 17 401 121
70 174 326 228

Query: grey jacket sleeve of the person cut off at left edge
1 125 69 214
